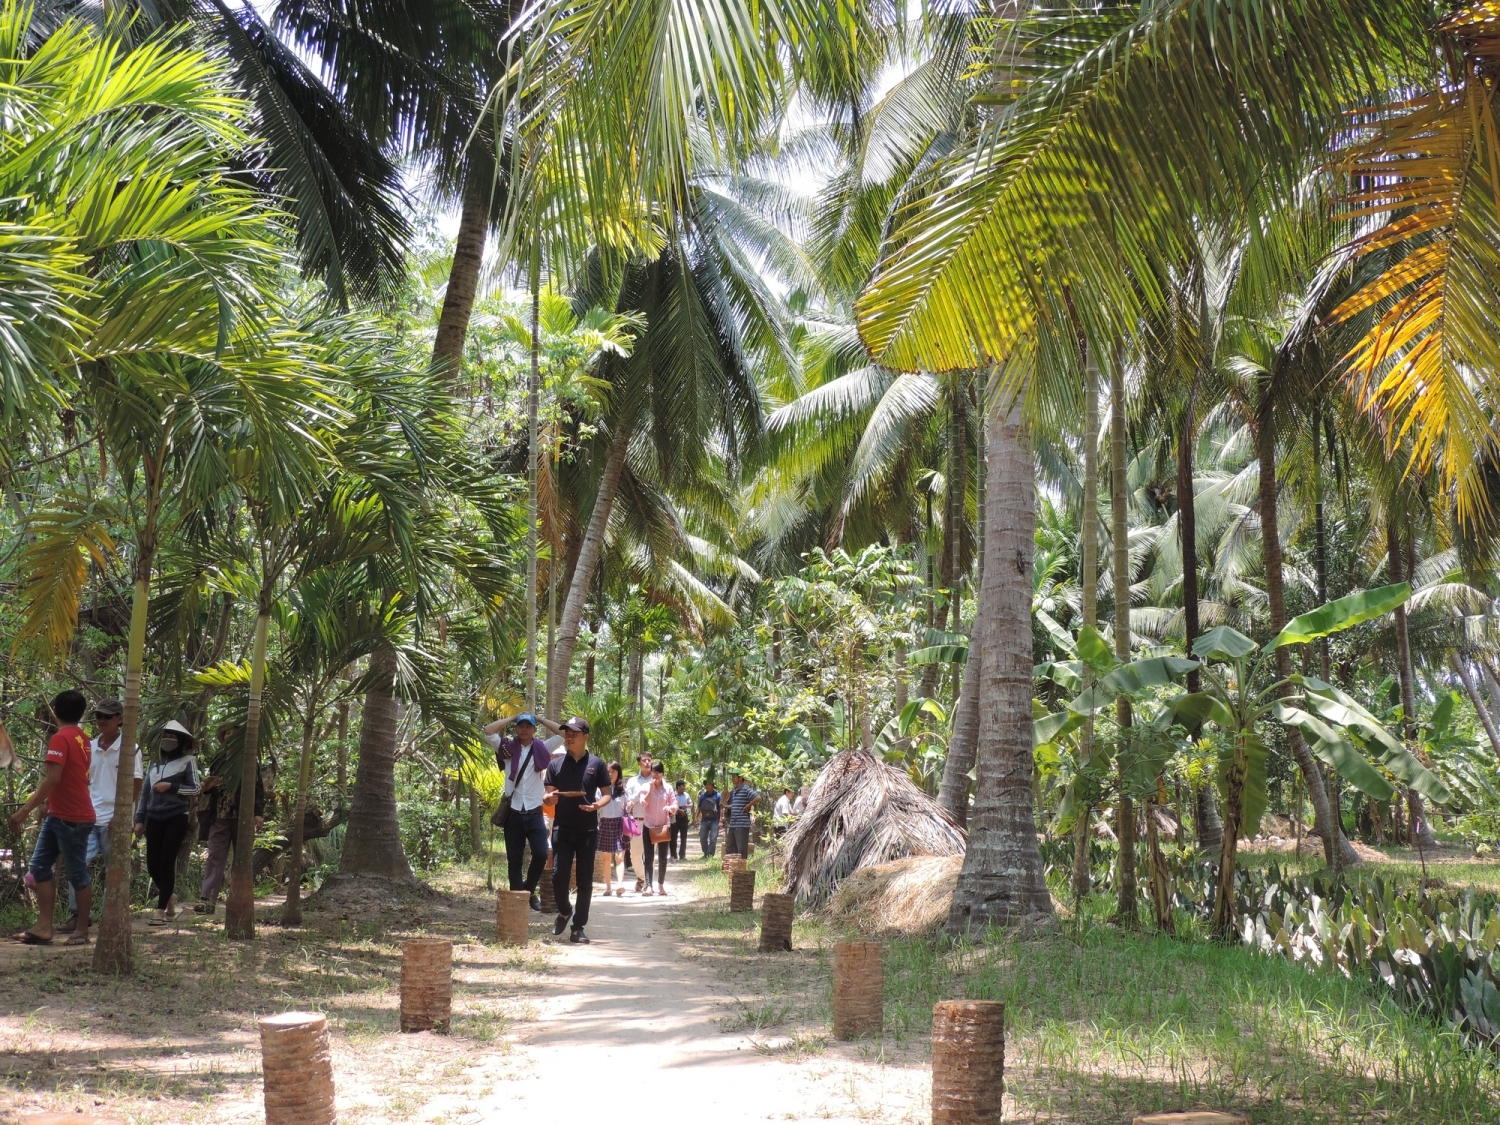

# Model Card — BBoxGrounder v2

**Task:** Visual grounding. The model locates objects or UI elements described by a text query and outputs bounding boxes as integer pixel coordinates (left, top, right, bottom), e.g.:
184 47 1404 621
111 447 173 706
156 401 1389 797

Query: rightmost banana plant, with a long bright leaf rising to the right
1175 582 1451 936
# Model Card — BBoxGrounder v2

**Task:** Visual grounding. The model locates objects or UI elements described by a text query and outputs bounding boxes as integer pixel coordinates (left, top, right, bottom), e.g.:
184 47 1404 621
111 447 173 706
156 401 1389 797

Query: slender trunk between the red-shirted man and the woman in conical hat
93 561 156 975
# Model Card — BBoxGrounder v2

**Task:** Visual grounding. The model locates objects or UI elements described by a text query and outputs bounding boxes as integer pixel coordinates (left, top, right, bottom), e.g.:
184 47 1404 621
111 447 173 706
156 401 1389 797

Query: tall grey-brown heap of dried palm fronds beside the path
782 750 968 902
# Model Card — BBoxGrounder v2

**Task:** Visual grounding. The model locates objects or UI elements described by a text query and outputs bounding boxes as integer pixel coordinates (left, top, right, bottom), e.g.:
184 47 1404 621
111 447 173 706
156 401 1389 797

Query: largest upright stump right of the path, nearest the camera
933 1001 1005 1125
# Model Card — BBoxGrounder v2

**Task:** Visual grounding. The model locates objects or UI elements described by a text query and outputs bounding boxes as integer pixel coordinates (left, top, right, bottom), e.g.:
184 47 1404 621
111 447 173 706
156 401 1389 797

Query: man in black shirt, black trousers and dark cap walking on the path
546 716 611 945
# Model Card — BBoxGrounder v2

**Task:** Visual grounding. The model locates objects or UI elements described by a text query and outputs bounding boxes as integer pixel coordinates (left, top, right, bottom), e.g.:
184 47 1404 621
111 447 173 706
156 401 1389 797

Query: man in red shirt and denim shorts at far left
11 690 95 945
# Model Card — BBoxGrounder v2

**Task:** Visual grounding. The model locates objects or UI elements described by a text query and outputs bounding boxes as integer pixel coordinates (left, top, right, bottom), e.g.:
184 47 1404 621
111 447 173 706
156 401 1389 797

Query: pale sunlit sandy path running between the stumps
419 885 930 1125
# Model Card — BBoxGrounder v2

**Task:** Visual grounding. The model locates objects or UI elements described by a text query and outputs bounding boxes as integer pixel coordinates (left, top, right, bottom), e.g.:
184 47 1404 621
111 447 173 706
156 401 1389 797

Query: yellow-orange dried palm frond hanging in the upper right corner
1332 0 1500 524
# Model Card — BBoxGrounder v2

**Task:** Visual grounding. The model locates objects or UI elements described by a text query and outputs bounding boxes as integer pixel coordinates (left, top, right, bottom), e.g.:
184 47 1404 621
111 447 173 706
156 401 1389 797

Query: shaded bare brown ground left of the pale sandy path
0 872 552 1125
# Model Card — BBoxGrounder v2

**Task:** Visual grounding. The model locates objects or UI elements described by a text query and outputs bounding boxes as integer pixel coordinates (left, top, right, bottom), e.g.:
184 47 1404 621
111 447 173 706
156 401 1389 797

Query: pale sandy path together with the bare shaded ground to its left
0 873 929 1125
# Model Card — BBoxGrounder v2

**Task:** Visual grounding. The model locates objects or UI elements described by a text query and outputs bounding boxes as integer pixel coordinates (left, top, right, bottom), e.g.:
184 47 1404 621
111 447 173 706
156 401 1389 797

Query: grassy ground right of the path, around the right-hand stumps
677 867 1500 1125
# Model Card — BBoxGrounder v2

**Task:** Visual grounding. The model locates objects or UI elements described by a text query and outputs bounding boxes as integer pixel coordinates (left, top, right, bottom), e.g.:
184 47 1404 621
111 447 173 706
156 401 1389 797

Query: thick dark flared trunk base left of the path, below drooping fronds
339 651 411 879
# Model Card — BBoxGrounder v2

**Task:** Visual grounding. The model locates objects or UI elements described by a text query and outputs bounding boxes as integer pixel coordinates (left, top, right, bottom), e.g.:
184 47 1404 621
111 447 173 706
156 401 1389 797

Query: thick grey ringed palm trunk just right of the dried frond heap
948 386 1052 933
